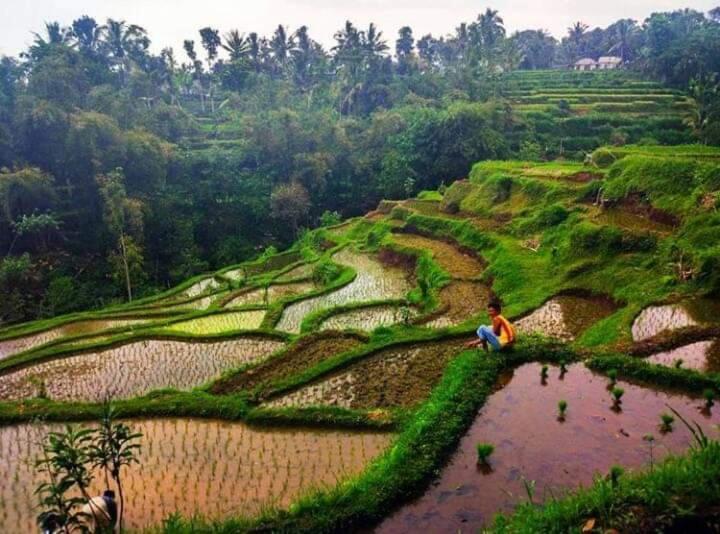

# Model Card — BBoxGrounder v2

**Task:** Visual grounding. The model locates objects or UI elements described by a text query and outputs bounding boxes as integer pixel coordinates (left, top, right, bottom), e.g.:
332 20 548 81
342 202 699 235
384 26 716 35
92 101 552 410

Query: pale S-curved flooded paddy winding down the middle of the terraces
276 248 410 333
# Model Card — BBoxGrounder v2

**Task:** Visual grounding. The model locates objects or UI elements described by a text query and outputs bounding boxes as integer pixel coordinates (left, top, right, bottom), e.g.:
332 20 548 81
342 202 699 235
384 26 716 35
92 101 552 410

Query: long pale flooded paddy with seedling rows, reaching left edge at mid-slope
0 337 283 401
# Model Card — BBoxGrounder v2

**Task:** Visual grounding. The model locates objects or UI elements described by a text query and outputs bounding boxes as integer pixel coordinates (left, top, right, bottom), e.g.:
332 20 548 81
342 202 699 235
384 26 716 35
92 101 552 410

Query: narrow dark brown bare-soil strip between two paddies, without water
212 332 362 394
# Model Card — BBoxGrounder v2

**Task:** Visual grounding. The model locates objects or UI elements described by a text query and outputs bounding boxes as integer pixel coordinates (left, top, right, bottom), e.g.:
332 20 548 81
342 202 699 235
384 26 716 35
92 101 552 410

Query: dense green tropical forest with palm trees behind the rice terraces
0 9 720 322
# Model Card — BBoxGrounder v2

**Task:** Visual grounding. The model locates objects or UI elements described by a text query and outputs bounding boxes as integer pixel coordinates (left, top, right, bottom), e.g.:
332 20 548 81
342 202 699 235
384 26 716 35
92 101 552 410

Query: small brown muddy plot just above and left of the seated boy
425 281 490 328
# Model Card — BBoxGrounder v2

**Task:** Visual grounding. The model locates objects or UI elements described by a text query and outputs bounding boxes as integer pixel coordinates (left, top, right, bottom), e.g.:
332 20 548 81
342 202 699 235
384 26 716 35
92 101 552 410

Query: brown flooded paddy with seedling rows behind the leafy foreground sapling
0 419 392 532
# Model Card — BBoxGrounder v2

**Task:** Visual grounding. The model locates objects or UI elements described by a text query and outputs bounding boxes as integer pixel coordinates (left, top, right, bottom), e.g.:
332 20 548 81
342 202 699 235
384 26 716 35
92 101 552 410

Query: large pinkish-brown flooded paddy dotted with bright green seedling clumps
376 363 720 533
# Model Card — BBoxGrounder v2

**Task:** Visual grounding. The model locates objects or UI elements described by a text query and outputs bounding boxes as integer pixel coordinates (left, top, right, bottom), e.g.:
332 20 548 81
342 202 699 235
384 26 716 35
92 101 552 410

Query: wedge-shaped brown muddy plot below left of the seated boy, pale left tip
267 340 463 408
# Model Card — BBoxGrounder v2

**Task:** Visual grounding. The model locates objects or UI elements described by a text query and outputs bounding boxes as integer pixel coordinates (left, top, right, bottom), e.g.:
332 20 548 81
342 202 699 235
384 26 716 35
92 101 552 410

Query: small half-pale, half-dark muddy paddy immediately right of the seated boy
515 295 617 341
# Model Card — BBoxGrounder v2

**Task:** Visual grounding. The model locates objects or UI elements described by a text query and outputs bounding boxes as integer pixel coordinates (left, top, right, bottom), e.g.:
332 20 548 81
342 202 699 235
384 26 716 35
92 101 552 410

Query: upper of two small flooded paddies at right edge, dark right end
632 298 720 341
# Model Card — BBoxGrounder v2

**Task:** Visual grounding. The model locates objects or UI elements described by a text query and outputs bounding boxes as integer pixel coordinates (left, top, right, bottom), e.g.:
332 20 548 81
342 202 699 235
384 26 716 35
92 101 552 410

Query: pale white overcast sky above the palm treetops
0 0 720 57
